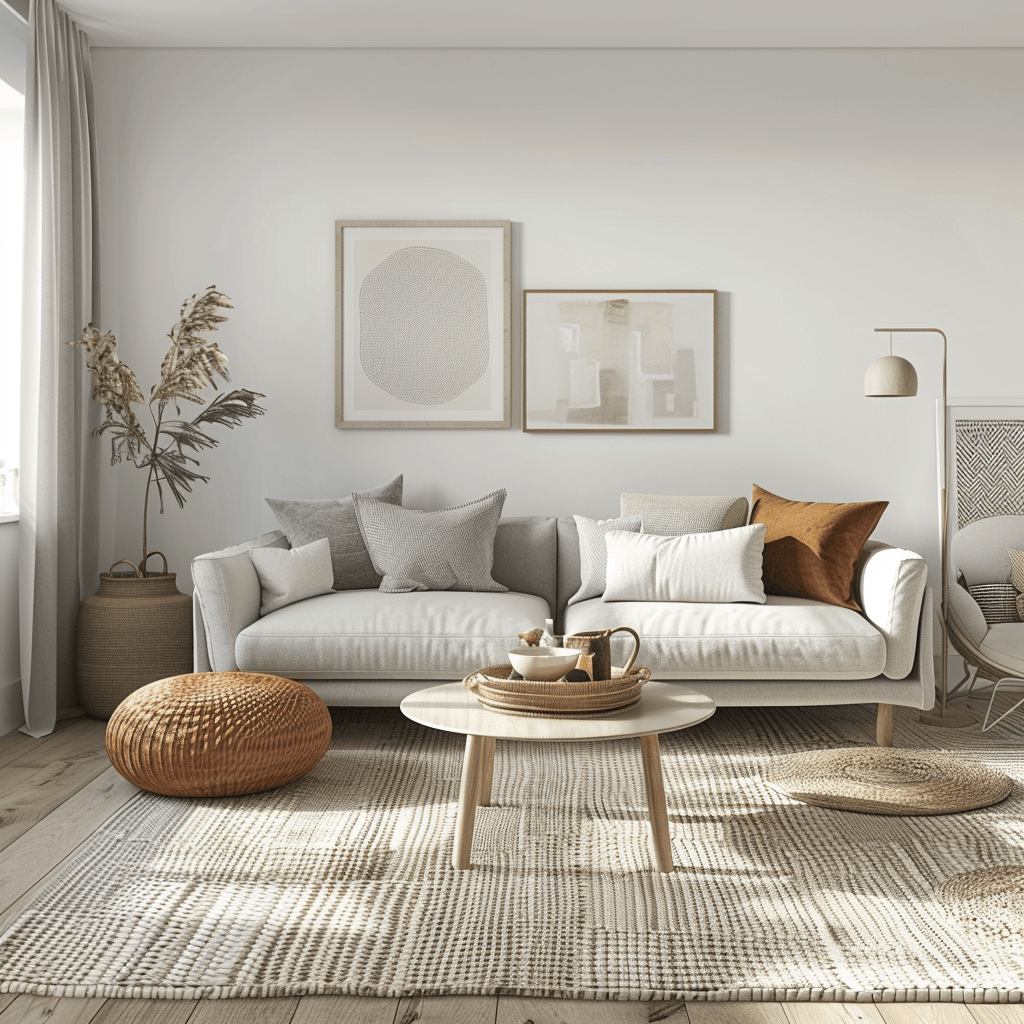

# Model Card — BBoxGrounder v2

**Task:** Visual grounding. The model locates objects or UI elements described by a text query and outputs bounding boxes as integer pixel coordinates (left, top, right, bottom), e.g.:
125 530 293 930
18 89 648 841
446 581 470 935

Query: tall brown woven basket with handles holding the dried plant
75 551 193 718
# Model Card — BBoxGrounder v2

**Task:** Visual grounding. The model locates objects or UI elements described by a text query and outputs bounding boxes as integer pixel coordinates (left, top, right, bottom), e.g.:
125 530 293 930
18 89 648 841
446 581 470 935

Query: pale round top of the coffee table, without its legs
401 682 715 742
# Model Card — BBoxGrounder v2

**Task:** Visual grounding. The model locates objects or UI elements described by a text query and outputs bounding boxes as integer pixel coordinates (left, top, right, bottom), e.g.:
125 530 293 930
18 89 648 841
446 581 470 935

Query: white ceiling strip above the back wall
49 0 1024 47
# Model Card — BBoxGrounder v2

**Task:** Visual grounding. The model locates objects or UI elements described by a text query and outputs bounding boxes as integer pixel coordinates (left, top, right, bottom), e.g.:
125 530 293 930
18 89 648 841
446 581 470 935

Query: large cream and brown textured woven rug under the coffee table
0 708 1024 1001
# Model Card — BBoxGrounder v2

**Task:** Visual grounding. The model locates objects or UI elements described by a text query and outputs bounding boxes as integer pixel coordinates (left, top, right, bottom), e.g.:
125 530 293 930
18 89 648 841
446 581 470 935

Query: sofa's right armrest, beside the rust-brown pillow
853 541 928 679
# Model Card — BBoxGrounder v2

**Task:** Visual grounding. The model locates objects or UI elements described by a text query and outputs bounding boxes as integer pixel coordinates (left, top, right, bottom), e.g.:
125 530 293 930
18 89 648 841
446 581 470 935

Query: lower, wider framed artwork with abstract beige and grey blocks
522 289 718 431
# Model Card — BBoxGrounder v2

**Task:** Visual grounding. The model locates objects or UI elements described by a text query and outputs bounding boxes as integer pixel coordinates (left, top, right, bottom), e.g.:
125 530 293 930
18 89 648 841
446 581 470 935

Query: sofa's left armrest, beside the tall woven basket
193 529 288 672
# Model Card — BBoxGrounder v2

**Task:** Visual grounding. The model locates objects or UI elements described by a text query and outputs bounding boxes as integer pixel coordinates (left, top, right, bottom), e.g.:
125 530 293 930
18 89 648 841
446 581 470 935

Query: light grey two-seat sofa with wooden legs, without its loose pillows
193 516 935 743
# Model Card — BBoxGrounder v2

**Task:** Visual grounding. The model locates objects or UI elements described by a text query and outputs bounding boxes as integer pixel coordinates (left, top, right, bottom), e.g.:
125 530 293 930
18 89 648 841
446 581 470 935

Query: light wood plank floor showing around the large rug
0 709 1024 1024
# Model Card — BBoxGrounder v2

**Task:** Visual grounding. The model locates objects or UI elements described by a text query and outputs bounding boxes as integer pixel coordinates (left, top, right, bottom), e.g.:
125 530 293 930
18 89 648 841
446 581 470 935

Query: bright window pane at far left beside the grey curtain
0 74 25 516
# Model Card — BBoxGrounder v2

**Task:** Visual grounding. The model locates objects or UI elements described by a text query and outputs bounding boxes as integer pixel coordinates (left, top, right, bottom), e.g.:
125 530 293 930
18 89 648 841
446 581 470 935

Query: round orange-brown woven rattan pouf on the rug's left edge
106 672 331 797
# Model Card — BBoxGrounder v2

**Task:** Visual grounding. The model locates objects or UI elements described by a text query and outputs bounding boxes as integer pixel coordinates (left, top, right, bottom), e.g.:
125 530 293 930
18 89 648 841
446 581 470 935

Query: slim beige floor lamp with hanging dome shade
864 327 975 729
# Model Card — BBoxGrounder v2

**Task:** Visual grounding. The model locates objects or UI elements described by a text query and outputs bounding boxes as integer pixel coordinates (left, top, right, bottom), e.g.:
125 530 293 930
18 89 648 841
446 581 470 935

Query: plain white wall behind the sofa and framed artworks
93 49 1024 589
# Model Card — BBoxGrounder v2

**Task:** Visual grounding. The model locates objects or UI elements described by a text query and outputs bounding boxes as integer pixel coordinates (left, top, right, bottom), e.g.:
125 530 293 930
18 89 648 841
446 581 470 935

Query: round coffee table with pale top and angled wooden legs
401 683 715 871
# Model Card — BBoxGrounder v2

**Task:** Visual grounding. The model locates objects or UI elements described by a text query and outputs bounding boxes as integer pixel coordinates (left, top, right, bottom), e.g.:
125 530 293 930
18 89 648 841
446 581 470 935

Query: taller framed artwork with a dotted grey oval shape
335 220 512 427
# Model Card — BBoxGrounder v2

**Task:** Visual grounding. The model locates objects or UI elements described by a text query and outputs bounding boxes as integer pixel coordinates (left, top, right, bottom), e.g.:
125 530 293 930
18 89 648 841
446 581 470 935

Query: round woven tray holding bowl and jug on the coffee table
463 665 650 718
